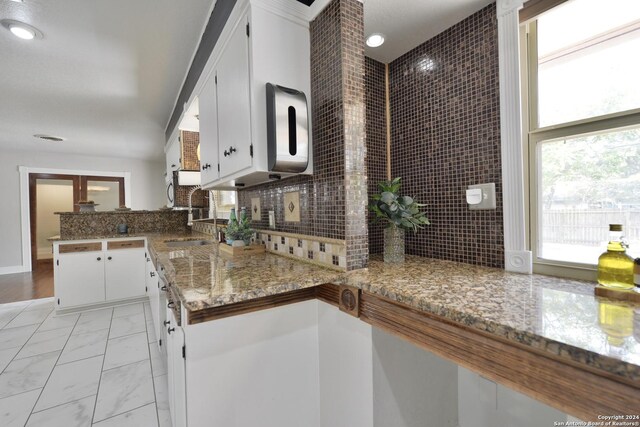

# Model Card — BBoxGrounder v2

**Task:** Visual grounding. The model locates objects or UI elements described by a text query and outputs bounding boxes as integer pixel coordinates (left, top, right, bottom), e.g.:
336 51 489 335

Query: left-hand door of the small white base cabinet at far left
55 251 105 308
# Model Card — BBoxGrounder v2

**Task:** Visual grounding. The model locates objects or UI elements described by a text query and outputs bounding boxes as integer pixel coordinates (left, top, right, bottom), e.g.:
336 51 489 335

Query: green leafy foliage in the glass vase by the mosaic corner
369 178 430 233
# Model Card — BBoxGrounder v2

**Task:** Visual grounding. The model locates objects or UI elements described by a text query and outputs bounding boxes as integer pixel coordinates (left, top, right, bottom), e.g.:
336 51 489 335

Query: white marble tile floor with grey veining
0 298 171 427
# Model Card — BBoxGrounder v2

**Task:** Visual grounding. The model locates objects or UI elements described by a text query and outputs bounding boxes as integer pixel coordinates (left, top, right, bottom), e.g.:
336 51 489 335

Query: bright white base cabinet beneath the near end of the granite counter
172 300 373 427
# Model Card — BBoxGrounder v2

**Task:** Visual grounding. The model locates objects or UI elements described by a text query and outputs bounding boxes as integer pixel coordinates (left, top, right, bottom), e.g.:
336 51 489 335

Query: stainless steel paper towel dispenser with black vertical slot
267 83 309 173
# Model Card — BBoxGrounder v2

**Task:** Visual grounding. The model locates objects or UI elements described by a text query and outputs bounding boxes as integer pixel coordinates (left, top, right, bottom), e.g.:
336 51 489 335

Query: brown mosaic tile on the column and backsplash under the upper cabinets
238 0 368 269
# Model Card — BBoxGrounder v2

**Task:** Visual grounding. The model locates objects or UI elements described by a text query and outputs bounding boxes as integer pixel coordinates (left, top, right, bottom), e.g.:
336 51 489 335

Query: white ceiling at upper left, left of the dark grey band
0 0 215 158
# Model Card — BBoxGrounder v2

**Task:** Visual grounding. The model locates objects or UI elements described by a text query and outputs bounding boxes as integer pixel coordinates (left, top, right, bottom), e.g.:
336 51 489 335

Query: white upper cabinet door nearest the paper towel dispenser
217 18 252 178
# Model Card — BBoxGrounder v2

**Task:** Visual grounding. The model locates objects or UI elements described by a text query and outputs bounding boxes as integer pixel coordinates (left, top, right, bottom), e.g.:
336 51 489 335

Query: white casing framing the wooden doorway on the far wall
18 166 132 274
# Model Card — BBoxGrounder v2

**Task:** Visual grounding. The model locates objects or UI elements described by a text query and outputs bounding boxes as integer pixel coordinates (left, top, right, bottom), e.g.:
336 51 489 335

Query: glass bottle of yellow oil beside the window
598 224 634 289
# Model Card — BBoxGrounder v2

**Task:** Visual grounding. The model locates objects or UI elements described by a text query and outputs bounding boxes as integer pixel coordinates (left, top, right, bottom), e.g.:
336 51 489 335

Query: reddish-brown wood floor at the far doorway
0 263 53 304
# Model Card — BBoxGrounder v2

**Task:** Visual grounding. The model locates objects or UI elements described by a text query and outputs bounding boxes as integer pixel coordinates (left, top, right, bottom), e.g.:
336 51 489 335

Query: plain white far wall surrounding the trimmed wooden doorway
0 148 165 272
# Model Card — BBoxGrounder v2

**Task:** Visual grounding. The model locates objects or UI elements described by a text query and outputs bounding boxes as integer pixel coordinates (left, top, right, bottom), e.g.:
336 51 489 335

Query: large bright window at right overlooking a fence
523 0 640 278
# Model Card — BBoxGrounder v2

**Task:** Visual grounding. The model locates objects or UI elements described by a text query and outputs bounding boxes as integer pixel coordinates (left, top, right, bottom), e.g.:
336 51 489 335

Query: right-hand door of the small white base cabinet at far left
105 248 146 301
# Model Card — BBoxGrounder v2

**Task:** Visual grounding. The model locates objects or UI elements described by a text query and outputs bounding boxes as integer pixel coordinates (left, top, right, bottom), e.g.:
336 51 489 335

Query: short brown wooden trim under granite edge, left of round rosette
188 284 338 325
